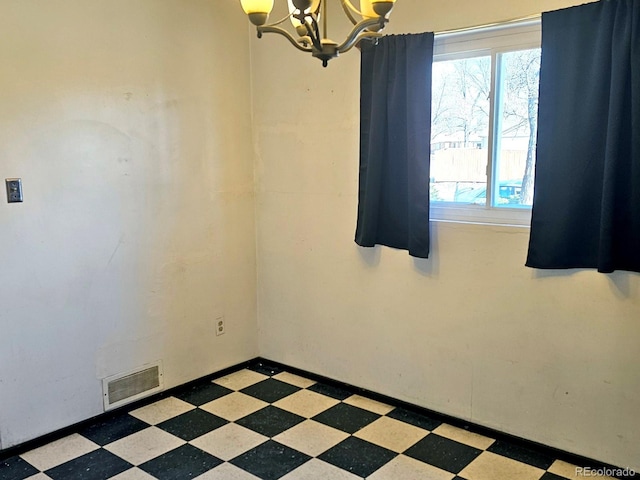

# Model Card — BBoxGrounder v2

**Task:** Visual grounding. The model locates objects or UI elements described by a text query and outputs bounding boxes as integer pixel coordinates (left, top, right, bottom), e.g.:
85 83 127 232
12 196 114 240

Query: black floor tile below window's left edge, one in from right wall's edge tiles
404 433 482 473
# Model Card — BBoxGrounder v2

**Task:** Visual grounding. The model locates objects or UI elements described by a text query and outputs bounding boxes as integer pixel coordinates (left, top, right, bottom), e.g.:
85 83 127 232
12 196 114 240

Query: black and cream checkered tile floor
0 364 620 480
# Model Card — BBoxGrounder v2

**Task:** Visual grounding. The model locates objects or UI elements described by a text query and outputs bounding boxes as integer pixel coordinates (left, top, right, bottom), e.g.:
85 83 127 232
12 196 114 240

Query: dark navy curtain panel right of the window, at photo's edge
526 0 640 273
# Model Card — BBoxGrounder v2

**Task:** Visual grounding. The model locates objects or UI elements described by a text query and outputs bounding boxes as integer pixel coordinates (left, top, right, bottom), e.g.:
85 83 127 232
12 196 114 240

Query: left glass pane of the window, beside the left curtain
430 56 491 205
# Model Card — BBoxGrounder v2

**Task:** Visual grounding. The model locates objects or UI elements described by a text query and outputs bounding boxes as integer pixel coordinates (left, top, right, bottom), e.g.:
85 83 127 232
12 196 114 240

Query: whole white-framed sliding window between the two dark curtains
430 20 540 225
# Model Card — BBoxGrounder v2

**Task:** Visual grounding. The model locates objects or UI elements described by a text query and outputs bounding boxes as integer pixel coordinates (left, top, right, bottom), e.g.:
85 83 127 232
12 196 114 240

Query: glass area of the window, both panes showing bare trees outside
431 48 540 206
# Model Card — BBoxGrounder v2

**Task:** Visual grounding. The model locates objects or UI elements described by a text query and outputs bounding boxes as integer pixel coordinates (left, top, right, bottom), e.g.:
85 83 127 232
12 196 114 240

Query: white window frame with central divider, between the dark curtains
430 18 542 226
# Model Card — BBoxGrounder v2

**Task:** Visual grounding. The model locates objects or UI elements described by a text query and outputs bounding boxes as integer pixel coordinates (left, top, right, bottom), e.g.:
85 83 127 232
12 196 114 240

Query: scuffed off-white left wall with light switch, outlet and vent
0 0 257 448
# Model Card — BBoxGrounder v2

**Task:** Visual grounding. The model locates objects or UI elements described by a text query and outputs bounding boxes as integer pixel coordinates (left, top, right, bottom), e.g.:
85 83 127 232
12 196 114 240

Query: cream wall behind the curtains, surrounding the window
251 0 640 470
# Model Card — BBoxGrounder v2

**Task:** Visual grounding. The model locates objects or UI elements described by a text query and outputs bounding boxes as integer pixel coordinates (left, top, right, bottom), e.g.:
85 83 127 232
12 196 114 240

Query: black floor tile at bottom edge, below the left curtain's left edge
318 437 397 477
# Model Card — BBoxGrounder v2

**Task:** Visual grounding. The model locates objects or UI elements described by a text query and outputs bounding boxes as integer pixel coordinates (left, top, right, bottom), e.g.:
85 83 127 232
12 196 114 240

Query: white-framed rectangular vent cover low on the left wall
102 362 162 411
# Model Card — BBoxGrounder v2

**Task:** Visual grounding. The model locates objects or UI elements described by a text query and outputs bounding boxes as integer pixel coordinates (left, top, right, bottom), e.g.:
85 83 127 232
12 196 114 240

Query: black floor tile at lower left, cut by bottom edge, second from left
44 448 133 480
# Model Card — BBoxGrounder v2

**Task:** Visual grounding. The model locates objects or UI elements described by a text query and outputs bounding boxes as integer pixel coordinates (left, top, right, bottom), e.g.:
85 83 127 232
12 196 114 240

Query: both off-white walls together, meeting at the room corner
5 0 640 469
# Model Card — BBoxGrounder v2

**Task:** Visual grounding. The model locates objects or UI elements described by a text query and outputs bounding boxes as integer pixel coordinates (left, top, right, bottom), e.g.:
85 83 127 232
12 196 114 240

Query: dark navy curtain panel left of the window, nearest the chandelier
356 33 433 258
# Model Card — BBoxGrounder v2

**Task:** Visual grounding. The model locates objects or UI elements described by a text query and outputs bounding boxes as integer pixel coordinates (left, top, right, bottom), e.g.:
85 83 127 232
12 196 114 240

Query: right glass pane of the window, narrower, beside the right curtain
493 48 540 207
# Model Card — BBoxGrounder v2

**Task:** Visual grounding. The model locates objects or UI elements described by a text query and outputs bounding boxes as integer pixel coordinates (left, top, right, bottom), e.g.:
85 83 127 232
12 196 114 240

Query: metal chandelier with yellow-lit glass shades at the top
240 0 396 67
